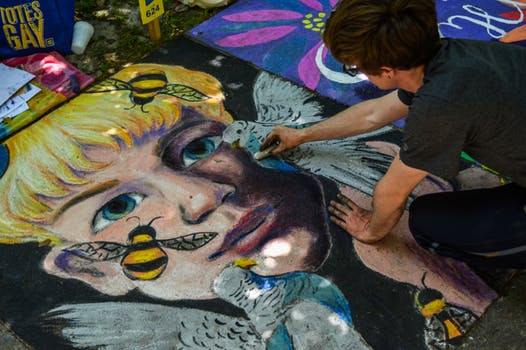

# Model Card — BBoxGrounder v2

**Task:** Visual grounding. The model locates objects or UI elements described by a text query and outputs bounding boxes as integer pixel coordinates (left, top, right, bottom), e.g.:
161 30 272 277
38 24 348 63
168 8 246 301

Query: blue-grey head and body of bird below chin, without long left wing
214 266 370 350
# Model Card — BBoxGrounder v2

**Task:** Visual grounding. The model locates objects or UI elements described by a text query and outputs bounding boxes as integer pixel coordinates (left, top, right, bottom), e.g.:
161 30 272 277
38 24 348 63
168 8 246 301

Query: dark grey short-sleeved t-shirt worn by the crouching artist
398 39 526 186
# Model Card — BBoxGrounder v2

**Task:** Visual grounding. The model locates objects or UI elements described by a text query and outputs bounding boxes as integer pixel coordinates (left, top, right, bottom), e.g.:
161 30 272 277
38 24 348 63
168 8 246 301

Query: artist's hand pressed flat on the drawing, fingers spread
329 193 383 243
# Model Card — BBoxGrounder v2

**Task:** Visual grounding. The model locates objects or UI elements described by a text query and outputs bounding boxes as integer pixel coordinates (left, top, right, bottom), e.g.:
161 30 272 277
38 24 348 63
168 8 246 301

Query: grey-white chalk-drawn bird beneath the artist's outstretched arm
223 72 393 195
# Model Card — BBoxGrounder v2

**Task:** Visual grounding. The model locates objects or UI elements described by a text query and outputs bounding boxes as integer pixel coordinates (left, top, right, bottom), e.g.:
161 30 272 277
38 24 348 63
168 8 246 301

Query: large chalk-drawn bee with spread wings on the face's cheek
63 217 217 281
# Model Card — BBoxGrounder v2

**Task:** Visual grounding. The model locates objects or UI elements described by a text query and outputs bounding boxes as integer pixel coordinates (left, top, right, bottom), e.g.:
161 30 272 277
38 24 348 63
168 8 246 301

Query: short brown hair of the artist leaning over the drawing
323 0 440 74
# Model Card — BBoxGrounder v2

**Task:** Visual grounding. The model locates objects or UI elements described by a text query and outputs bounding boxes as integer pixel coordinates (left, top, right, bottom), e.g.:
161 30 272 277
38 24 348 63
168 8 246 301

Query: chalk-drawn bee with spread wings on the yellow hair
87 69 209 113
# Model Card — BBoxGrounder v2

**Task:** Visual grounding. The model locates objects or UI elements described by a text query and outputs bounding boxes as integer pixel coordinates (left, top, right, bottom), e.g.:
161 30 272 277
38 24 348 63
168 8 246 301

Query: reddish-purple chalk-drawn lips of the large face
208 204 273 260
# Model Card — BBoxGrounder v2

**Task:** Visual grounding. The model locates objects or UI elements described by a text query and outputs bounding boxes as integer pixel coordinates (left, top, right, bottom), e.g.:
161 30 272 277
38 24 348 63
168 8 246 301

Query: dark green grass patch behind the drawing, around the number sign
72 0 222 80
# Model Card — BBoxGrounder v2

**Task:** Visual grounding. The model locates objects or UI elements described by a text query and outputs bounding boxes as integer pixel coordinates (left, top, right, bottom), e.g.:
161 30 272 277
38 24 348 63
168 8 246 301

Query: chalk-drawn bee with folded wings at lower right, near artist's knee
415 273 477 349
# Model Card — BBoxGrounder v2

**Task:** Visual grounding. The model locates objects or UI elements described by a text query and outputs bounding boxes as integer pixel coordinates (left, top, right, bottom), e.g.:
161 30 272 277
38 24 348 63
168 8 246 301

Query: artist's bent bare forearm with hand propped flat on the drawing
329 156 428 243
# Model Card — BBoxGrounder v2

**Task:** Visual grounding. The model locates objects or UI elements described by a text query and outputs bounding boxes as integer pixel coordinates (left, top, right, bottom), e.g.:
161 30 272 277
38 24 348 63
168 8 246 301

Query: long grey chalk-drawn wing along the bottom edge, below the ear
46 302 264 350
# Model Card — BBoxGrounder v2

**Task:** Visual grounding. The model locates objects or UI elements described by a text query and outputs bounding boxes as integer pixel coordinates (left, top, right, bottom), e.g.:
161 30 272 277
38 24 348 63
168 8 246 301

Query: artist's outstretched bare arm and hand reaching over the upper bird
260 91 408 154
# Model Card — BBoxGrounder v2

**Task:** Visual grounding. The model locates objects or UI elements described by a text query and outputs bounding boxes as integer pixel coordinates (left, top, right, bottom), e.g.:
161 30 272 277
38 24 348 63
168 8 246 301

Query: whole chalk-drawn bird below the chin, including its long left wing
46 264 370 350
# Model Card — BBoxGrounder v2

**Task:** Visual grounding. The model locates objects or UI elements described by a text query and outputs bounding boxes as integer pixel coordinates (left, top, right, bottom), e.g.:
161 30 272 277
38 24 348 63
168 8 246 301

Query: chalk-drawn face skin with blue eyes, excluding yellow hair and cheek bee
42 109 328 299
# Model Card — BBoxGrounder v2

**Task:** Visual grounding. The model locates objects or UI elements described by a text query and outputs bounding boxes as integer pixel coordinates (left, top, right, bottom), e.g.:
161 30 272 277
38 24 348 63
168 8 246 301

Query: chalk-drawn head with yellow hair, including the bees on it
0 64 330 299
